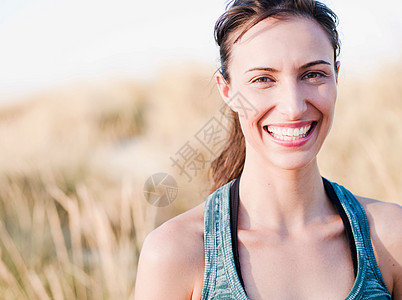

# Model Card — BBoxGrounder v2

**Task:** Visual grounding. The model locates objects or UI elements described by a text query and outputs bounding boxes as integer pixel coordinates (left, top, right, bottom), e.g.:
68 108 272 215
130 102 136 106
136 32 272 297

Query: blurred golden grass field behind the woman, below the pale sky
0 63 402 300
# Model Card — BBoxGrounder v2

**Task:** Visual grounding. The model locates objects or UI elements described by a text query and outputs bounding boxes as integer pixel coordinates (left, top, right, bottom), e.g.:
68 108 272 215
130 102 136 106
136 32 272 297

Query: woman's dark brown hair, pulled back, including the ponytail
210 0 340 191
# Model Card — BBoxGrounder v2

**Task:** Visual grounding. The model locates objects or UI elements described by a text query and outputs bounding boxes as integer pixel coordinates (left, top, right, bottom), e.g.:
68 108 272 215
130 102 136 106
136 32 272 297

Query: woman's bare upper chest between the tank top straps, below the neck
238 227 354 300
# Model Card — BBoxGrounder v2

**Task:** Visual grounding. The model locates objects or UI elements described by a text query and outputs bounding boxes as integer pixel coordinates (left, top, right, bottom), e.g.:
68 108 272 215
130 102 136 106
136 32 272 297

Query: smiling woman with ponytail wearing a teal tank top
136 0 402 300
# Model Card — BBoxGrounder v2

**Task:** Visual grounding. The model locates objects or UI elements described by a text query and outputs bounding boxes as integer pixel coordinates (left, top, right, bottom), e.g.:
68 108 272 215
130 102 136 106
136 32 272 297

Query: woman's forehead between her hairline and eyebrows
231 17 334 67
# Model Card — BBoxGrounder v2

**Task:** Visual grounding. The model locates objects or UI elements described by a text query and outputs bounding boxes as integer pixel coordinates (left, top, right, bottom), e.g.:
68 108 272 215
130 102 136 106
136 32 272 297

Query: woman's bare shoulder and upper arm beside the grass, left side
135 203 204 300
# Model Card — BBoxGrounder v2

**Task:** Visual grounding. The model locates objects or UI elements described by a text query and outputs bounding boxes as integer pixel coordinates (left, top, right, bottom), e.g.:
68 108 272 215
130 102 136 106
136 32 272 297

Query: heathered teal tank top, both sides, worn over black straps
201 181 391 300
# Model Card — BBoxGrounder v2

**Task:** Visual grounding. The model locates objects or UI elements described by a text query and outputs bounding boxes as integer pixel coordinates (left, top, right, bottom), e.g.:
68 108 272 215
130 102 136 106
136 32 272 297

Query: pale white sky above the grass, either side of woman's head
0 0 402 102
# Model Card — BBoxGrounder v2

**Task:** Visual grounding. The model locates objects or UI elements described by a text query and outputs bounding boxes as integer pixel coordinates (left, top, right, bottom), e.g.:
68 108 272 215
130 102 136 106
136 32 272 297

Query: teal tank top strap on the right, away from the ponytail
330 182 391 300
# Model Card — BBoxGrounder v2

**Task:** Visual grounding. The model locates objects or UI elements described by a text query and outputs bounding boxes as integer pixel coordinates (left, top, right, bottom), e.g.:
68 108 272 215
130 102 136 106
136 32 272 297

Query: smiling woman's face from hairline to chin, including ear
217 17 339 169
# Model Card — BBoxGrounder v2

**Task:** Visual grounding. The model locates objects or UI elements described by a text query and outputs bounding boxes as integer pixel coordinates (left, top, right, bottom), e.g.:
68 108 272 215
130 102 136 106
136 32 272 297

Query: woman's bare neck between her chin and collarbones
239 150 333 231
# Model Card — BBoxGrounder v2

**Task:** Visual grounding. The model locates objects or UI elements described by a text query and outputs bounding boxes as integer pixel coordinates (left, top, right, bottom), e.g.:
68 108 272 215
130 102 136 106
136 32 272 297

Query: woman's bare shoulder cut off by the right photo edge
356 197 402 297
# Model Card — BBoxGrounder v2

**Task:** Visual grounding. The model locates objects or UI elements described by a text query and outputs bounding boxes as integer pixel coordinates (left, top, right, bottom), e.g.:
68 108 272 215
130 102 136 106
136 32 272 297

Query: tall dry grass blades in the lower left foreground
0 172 156 299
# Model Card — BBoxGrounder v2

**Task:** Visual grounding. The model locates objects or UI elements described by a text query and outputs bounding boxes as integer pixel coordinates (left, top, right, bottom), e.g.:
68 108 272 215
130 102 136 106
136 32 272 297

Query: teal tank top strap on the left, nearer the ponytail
201 181 248 300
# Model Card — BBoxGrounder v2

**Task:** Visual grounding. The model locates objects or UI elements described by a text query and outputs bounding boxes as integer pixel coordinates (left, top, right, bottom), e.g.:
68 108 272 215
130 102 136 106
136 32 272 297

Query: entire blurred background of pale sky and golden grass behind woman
0 0 402 299
